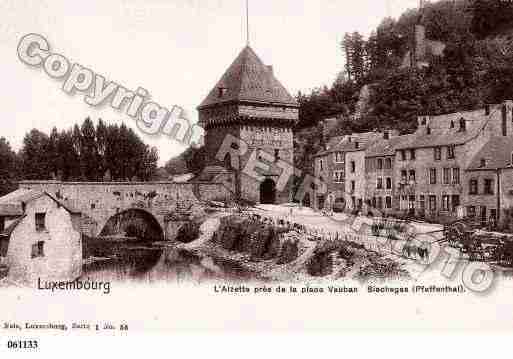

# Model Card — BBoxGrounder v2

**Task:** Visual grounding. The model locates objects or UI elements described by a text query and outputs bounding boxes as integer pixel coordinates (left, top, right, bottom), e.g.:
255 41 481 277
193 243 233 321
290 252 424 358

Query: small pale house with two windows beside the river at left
0 189 82 286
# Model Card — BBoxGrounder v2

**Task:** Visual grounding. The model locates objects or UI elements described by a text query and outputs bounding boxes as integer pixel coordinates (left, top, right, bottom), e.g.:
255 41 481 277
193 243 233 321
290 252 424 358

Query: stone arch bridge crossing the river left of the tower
19 181 234 240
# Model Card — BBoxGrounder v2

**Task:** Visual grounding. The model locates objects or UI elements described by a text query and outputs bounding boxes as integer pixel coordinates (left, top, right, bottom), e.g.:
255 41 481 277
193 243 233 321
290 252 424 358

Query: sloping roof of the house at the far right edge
467 136 513 171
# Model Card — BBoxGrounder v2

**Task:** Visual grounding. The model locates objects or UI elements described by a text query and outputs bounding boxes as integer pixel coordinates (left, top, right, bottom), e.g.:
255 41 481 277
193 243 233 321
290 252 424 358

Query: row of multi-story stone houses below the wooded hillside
313 101 513 226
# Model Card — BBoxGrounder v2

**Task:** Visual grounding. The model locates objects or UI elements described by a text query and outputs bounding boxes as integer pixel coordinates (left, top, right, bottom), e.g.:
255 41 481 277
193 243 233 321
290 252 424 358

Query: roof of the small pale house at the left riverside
0 188 81 216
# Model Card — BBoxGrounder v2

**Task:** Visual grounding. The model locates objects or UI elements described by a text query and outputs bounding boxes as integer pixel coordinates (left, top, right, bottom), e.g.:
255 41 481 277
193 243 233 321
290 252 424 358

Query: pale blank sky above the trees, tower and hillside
0 0 418 165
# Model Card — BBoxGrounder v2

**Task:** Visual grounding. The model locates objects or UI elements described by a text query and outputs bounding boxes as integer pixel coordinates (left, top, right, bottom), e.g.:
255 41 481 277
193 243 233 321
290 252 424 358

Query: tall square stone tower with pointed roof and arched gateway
198 46 299 203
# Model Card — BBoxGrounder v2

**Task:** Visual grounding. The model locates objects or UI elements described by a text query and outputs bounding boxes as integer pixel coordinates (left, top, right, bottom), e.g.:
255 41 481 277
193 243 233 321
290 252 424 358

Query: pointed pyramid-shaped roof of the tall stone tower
198 46 298 109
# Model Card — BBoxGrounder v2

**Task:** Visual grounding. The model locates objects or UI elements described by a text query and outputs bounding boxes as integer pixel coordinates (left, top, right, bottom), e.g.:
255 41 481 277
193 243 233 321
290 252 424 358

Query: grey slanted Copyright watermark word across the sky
17 34 204 146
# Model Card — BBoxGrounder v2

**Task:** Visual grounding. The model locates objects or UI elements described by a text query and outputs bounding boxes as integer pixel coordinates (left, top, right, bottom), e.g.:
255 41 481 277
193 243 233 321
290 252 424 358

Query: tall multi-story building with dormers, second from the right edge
394 101 513 221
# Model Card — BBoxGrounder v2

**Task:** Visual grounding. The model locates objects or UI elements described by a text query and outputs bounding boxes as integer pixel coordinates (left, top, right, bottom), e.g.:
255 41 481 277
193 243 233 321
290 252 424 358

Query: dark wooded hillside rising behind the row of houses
295 0 513 179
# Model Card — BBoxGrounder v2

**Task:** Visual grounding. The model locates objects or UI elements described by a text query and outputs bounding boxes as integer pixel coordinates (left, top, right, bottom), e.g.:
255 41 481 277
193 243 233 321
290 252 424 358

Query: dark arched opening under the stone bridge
99 208 165 242
